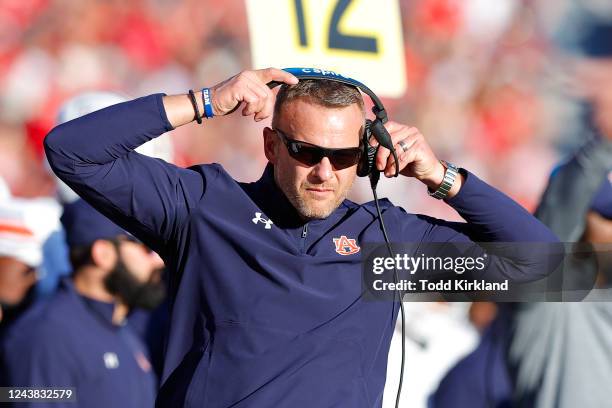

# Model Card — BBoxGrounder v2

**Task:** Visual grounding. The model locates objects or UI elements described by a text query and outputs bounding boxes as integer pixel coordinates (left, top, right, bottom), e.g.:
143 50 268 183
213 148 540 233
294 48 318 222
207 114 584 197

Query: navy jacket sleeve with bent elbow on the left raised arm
44 94 210 256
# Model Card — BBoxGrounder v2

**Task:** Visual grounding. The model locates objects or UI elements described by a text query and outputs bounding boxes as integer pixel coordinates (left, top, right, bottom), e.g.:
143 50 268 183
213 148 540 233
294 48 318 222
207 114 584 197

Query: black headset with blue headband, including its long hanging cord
268 68 406 408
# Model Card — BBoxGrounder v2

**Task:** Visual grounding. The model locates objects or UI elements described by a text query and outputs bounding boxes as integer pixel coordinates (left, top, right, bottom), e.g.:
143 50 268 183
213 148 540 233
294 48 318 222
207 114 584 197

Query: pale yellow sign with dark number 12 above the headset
246 0 406 98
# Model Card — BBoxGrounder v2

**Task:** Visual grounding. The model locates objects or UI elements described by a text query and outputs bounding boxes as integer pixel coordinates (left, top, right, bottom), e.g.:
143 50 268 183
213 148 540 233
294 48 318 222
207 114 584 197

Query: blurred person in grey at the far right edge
508 57 612 408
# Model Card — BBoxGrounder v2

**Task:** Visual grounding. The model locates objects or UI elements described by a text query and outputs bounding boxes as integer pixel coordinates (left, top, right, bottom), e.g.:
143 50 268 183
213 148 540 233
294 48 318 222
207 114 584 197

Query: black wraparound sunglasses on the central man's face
274 129 361 170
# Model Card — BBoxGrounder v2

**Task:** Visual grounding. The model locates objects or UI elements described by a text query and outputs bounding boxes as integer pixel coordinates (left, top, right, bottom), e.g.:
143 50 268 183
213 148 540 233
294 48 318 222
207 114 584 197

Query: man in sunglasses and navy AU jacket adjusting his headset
45 69 556 407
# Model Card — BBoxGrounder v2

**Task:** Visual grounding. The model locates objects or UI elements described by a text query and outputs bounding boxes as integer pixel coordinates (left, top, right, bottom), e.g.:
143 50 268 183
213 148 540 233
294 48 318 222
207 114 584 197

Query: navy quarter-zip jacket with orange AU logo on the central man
45 94 557 408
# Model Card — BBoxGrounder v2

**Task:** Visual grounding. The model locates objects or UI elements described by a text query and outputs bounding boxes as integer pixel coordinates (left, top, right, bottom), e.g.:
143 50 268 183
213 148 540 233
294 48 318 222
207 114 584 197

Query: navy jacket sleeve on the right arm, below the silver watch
394 170 563 283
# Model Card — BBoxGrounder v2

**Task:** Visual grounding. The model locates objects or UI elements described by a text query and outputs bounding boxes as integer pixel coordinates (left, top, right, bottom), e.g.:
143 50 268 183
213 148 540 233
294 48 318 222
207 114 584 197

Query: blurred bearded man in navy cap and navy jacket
1 200 165 408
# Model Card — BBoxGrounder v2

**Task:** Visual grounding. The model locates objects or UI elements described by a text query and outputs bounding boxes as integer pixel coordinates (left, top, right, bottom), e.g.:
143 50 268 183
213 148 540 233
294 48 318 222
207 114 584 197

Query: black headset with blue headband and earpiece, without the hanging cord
268 68 399 182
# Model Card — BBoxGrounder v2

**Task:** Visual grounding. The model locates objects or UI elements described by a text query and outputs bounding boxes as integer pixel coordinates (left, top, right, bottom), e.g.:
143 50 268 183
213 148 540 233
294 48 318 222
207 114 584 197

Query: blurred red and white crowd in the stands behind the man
0 0 610 210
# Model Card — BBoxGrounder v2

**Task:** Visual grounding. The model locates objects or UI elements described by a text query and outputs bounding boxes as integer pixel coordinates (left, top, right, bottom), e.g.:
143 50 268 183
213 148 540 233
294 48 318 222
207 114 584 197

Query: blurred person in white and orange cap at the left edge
0 178 60 335
